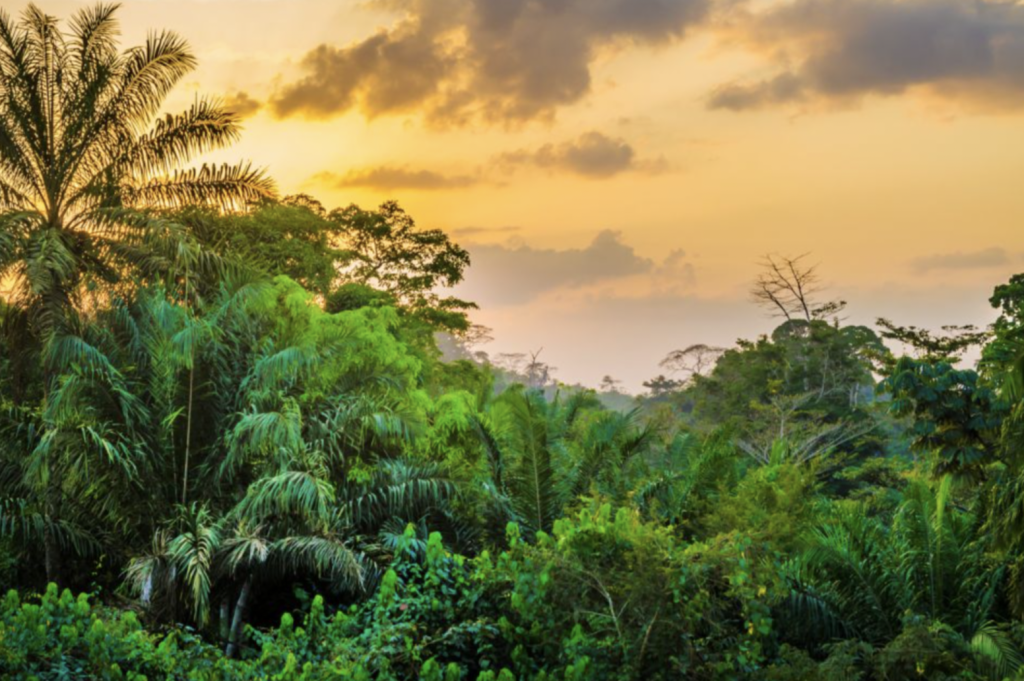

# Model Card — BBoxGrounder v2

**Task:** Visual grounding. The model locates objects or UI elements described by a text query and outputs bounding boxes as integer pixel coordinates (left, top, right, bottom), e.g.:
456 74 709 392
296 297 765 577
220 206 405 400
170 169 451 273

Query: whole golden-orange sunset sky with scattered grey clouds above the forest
8 0 1024 391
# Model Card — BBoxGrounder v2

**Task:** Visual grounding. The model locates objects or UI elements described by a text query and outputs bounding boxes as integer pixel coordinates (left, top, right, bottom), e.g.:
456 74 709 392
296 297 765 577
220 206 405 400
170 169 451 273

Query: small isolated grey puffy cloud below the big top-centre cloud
499 131 668 178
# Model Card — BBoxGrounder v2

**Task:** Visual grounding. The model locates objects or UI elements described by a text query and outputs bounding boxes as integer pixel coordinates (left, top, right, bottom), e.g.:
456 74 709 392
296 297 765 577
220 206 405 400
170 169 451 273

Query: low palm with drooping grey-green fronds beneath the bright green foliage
126 461 454 656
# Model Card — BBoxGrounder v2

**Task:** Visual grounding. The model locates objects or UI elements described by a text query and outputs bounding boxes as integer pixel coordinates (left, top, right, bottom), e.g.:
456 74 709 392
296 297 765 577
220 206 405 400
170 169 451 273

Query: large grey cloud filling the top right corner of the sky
708 0 1024 111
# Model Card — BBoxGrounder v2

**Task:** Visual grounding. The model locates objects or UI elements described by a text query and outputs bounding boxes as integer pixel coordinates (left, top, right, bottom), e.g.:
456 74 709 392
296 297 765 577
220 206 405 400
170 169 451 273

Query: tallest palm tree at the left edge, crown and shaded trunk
0 4 273 579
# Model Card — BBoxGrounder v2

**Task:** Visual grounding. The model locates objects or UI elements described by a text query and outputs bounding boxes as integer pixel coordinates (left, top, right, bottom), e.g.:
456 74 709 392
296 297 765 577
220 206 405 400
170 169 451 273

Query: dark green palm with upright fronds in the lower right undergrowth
785 476 1024 679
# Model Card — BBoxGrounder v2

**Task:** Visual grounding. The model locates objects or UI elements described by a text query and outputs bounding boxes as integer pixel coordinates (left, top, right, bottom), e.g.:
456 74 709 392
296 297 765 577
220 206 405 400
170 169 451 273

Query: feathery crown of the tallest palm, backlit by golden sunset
0 4 272 337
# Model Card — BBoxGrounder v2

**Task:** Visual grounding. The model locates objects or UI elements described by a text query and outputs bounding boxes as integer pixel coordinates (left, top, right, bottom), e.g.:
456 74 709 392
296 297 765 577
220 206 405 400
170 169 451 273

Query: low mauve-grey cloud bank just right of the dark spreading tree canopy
462 230 654 306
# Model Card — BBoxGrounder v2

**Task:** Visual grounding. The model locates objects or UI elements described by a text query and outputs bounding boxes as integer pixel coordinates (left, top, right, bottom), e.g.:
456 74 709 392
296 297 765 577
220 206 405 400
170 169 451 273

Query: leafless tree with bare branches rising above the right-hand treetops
751 253 846 322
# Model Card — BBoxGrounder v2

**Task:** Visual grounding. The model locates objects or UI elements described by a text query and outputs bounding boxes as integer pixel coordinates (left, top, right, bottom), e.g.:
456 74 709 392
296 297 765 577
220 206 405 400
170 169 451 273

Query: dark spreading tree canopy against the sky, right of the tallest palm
186 195 476 340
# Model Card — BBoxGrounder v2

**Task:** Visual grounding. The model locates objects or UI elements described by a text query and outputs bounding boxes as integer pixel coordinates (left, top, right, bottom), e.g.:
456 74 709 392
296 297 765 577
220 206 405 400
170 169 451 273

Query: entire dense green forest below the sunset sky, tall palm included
0 5 1024 681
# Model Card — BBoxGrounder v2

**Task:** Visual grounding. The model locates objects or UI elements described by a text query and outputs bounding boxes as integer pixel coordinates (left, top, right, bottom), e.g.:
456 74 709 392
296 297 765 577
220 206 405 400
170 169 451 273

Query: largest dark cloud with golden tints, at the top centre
270 0 713 126
